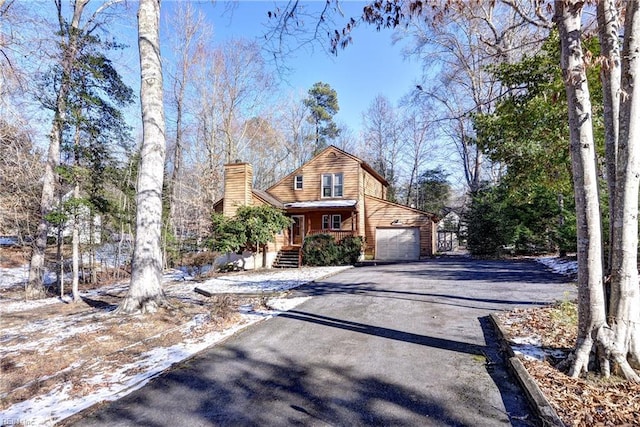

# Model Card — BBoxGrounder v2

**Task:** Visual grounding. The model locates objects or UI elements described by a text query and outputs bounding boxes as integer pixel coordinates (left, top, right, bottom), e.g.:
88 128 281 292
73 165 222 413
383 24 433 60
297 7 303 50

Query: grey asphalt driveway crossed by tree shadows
72 258 574 426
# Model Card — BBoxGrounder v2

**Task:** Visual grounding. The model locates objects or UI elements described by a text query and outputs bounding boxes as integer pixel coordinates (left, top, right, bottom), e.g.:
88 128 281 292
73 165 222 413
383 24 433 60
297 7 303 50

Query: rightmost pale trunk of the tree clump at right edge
610 0 640 382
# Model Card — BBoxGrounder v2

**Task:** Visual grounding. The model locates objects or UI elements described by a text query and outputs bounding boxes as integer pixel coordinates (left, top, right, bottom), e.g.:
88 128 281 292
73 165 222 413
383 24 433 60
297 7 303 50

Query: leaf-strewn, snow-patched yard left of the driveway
0 266 346 426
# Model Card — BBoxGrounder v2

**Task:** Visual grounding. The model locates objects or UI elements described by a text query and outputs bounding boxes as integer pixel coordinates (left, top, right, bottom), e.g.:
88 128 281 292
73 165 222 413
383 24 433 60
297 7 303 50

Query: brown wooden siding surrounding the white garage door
365 197 436 257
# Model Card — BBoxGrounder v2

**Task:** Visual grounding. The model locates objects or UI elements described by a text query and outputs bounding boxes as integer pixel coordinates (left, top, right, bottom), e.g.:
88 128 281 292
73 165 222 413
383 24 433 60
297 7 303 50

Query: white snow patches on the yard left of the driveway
0 267 350 426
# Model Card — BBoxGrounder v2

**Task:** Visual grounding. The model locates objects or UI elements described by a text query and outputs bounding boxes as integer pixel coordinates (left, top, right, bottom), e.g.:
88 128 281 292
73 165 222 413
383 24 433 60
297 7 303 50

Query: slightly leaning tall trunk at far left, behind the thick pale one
25 0 89 299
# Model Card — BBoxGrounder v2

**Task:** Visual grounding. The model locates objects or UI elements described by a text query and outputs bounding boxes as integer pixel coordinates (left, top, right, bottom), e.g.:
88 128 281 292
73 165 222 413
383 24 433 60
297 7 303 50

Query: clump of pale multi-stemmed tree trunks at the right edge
555 0 640 382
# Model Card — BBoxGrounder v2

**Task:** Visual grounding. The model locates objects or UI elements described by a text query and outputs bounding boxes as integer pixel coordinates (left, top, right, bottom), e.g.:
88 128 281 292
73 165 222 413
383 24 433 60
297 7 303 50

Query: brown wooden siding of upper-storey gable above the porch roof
268 149 360 203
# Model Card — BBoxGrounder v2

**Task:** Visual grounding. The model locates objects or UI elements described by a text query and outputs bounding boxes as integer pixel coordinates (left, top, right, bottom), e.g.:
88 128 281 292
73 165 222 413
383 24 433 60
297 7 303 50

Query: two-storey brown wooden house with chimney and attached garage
214 146 438 268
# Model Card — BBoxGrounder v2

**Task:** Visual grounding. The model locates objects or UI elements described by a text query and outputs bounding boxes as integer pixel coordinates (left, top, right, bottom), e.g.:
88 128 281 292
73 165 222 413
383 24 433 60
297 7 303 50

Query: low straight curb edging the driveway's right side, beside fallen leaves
489 314 566 427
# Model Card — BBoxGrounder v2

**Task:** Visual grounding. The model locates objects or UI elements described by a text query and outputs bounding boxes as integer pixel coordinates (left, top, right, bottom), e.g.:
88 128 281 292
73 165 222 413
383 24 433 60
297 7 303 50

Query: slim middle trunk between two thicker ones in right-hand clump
597 0 620 273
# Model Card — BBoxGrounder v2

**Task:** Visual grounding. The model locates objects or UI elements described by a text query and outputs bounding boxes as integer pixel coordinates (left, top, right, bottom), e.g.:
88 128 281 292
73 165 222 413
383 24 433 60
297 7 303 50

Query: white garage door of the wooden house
376 227 420 261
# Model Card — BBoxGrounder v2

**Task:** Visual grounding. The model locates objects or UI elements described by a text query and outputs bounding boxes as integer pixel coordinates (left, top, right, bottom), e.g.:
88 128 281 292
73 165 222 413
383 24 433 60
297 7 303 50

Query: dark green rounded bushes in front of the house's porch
302 234 363 266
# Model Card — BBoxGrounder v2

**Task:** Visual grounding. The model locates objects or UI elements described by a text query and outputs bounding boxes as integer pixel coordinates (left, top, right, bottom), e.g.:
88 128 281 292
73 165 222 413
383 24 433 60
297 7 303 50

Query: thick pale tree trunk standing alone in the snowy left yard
118 0 166 313
